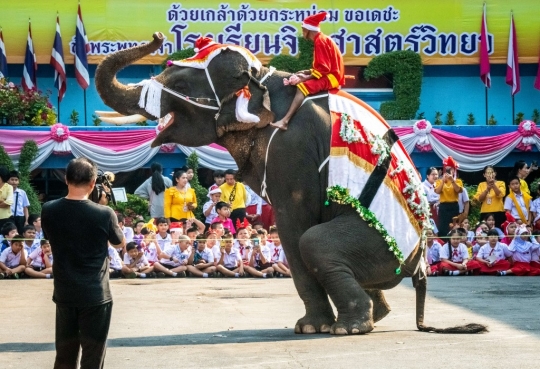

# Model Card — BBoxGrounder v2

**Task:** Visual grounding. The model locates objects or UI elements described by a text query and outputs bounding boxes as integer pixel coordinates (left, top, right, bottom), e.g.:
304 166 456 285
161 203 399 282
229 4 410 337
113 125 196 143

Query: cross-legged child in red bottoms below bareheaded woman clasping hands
467 229 512 275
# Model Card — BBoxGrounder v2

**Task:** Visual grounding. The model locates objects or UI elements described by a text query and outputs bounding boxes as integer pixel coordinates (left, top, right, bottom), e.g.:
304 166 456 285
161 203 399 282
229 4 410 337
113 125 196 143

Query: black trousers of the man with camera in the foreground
54 302 112 369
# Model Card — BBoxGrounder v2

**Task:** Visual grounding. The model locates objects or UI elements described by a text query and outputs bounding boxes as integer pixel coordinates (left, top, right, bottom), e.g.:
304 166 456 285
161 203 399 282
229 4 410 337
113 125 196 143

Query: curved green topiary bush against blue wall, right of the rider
364 50 423 120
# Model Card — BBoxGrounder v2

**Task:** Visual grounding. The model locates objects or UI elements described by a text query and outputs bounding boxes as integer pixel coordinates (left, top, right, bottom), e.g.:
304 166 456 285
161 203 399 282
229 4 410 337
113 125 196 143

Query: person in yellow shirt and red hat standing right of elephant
435 156 463 237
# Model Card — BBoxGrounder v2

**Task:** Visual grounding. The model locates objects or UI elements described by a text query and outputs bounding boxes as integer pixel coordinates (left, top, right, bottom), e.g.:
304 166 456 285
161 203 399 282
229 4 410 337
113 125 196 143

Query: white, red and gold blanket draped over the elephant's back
328 91 429 259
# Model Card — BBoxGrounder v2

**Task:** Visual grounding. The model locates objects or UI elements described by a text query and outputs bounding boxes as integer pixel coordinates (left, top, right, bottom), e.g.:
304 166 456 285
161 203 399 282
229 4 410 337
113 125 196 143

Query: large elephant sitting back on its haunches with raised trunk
95 33 486 335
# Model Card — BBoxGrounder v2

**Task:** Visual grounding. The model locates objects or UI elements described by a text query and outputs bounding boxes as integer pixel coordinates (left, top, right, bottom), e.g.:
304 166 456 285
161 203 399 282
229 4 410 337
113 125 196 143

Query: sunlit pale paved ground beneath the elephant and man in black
0 277 540 369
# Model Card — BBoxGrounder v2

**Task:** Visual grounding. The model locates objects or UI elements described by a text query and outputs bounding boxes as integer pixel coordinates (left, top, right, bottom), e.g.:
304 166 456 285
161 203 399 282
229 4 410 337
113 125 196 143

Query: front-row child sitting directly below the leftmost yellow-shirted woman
154 235 191 278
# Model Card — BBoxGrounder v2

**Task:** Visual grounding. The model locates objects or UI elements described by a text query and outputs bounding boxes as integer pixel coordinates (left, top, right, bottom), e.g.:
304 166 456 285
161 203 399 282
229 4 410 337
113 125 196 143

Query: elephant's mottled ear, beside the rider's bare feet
217 73 274 130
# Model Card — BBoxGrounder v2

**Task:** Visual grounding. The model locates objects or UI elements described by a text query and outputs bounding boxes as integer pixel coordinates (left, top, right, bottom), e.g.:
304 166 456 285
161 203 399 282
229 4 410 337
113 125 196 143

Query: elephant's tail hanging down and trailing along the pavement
412 271 488 334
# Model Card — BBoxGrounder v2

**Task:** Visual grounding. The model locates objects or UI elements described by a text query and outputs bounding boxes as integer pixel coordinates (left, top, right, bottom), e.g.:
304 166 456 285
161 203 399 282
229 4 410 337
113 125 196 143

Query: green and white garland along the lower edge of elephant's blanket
325 185 405 274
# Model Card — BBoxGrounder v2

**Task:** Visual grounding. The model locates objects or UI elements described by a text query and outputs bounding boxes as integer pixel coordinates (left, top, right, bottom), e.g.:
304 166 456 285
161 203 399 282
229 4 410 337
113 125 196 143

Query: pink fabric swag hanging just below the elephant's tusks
70 129 156 152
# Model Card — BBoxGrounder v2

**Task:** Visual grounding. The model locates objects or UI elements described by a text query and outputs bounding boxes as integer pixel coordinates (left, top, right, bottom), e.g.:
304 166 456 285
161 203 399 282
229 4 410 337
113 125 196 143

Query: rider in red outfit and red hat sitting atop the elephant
271 12 345 130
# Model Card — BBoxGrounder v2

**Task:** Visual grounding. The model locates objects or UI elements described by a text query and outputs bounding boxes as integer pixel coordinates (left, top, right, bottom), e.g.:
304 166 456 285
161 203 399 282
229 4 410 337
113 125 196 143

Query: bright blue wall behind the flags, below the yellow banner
4 64 540 125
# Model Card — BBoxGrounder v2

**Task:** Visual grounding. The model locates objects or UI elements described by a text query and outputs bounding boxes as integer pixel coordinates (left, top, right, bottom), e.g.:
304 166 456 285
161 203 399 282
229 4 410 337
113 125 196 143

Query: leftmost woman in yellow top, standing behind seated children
163 170 197 222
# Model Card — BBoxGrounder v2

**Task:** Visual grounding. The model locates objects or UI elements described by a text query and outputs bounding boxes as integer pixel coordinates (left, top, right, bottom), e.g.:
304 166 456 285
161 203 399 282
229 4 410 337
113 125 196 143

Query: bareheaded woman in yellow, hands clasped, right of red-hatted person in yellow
474 165 506 227
